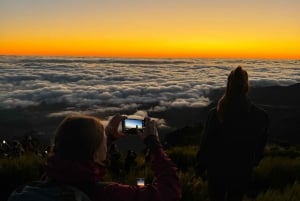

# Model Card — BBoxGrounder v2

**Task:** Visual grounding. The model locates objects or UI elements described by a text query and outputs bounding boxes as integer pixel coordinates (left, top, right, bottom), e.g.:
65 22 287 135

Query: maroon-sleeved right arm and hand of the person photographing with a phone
107 117 182 201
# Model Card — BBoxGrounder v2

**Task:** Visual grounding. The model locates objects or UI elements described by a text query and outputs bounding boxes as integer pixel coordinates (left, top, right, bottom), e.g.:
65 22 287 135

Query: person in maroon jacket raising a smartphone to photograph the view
10 115 182 201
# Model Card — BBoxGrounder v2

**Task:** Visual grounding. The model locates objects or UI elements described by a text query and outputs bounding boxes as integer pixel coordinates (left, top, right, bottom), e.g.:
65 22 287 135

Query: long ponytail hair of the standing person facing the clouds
217 66 249 121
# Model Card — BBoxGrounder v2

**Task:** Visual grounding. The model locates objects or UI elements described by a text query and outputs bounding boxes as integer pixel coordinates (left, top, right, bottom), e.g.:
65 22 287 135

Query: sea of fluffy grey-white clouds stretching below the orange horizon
0 56 300 116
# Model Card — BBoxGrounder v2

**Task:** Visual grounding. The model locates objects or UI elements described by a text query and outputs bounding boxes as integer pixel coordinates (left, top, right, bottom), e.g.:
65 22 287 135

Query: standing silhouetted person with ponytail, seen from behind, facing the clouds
196 66 269 201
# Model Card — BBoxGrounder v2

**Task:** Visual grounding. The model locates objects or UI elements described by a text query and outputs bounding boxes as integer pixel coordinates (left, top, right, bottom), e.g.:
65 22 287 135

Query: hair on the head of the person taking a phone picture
51 115 105 160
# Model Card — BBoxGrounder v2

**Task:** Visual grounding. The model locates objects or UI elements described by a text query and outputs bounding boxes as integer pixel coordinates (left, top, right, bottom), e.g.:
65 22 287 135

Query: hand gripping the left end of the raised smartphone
105 114 127 142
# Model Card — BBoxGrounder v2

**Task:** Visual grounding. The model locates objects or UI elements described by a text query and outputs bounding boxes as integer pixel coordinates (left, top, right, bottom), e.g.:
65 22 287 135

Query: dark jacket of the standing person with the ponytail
196 99 269 178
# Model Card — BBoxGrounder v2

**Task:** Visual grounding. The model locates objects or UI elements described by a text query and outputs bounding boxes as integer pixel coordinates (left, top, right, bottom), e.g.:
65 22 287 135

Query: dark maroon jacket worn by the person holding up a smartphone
47 137 181 201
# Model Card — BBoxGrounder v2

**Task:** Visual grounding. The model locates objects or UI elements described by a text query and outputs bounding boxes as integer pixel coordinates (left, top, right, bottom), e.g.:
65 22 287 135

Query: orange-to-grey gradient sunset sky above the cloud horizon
0 0 300 58
